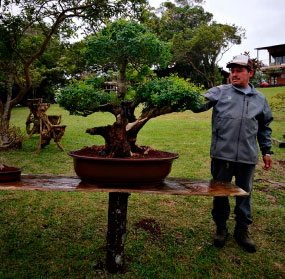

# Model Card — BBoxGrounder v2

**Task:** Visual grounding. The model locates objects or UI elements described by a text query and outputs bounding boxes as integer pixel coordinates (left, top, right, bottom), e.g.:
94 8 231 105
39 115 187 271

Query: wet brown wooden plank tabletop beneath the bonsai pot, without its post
0 174 248 196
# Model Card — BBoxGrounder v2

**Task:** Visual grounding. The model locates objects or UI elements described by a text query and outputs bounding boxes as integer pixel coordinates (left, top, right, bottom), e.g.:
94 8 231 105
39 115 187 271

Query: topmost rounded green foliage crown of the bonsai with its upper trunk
86 20 171 97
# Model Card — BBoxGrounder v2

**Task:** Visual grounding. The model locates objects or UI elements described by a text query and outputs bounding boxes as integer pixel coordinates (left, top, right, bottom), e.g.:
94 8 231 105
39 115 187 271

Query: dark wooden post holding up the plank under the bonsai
106 192 130 273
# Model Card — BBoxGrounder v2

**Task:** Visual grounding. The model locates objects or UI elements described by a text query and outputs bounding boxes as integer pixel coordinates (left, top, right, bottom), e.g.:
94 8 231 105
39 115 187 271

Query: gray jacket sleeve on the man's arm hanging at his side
257 99 273 155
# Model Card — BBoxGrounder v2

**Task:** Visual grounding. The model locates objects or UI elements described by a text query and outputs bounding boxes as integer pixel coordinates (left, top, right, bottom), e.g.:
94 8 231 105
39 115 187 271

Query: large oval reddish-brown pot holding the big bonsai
68 150 178 186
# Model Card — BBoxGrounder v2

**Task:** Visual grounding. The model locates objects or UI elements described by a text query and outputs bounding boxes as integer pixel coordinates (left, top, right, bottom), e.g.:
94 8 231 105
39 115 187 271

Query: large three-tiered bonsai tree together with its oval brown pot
57 20 203 185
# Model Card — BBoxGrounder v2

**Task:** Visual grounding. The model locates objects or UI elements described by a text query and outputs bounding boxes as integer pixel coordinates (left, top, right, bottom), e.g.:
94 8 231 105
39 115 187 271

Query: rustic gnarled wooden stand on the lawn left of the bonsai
26 98 66 152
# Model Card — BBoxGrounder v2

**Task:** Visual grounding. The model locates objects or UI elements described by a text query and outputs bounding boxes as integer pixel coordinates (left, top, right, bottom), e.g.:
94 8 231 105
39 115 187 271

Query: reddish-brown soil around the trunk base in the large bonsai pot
74 145 176 160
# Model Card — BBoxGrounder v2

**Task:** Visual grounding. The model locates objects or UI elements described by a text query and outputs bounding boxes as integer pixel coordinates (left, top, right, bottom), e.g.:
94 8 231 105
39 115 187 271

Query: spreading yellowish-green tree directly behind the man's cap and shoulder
173 22 241 88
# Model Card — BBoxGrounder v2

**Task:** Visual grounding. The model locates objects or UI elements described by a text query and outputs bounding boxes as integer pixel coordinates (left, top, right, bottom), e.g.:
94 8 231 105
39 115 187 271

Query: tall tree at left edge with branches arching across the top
0 0 145 148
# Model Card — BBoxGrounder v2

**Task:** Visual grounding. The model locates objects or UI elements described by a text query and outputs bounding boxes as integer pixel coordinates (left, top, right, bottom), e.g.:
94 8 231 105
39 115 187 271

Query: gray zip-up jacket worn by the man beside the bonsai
196 84 273 164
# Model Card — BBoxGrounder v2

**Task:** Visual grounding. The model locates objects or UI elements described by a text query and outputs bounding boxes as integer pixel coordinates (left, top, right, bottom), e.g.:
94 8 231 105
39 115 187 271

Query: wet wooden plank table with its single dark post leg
0 174 248 273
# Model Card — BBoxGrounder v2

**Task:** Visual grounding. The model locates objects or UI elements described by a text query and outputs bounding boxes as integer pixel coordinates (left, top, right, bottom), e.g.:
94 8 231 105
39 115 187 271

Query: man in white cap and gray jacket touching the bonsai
194 55 273 253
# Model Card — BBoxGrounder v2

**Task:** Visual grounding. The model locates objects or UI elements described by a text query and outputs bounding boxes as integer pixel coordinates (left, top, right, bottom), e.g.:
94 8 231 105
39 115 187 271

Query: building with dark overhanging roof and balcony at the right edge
256 44 285 86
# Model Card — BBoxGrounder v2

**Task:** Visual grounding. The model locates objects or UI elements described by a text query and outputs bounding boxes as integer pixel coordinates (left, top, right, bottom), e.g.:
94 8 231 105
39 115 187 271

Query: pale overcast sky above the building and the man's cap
149 0 285 69
